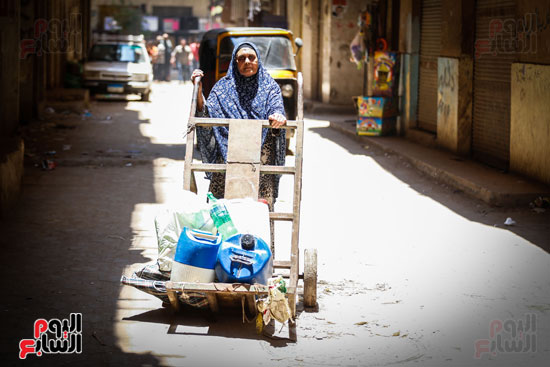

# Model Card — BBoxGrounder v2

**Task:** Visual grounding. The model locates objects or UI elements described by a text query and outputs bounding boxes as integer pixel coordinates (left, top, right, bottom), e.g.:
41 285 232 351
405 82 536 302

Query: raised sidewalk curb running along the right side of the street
329 121 550 207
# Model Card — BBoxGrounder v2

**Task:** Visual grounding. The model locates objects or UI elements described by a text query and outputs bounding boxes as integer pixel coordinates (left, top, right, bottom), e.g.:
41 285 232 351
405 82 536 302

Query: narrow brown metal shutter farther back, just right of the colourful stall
418 0 442 133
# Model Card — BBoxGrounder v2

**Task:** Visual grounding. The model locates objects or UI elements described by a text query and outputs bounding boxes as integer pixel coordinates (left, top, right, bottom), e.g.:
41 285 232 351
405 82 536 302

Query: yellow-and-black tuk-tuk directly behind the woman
199 27 302 146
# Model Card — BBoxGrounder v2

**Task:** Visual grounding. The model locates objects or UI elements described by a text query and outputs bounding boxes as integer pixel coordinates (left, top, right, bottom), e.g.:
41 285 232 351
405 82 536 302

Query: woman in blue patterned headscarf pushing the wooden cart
191 42 286 207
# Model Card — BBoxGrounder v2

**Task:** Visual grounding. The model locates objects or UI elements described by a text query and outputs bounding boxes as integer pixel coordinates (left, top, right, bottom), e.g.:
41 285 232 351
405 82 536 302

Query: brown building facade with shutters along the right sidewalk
287 0 550 184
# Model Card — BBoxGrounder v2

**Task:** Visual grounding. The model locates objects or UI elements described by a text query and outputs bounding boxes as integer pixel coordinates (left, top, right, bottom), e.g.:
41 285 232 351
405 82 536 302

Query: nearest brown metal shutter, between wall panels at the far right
472 0 516 169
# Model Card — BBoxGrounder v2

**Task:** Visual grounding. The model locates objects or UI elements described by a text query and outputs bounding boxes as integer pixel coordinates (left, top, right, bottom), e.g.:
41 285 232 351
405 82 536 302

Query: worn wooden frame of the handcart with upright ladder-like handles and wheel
166 73 317 324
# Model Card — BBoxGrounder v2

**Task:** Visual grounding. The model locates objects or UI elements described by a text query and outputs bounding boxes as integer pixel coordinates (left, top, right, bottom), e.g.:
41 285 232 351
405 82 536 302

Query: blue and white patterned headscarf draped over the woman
197 42 285 166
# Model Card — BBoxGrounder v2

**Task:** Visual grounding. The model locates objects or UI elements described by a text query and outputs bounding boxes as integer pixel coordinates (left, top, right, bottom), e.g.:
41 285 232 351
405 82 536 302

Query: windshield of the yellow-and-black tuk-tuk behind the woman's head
219 36 296 73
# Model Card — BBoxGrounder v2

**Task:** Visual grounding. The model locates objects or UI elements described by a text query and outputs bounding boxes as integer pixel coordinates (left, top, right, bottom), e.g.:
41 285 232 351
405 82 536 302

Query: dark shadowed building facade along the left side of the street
0 0 90 215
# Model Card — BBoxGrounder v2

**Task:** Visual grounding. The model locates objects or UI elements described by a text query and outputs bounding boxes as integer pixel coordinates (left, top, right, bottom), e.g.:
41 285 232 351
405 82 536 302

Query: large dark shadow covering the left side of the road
0 102 168 366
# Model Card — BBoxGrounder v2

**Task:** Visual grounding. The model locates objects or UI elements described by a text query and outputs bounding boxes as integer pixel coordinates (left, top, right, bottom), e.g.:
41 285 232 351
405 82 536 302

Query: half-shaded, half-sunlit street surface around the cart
0 82 550 366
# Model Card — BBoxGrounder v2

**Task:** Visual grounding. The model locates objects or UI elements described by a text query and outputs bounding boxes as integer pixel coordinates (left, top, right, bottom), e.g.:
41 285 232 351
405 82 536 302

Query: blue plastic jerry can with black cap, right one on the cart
215 234 273 285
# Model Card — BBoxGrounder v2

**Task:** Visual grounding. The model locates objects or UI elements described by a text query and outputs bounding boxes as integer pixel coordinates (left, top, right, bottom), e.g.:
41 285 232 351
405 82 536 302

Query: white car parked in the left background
84 34 153 101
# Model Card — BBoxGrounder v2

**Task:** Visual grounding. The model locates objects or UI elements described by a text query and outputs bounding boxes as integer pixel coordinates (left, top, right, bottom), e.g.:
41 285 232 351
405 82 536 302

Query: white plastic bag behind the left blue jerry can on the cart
155 191 217 272
